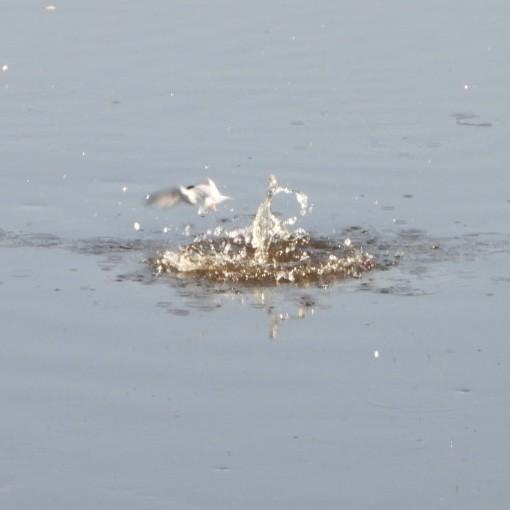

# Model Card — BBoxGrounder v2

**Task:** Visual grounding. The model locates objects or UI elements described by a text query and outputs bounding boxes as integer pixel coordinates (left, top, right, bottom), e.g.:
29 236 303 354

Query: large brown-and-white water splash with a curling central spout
149 175 375 285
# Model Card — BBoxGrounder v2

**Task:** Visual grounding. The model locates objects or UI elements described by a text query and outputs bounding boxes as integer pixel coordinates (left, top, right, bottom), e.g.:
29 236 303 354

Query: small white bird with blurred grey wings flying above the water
145 179 231 215
